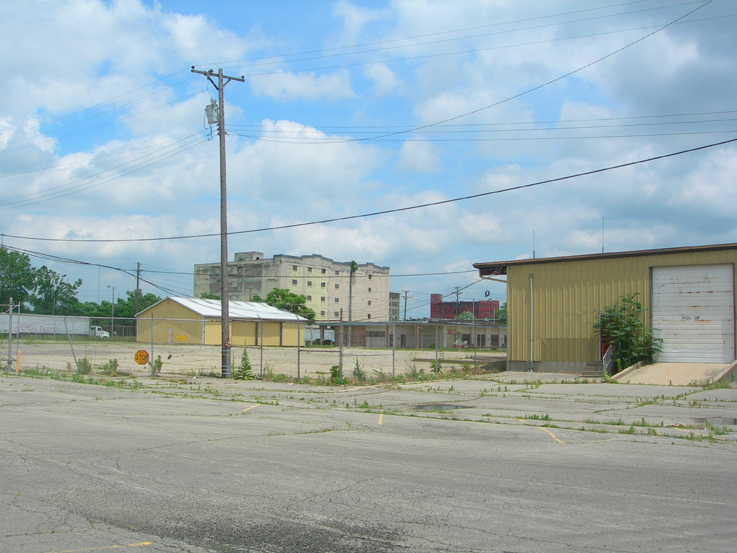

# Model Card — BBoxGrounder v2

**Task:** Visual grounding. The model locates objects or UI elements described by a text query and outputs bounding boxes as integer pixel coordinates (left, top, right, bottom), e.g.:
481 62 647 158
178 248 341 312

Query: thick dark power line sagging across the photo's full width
4 133 737 243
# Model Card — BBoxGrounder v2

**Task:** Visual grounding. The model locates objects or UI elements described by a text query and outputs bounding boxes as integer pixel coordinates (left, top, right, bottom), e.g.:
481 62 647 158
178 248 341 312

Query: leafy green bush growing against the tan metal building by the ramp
594 292 663 369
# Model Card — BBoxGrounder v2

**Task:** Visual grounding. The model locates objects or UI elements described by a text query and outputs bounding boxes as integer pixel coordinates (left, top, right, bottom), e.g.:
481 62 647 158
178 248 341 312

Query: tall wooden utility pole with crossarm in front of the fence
192 65 246 378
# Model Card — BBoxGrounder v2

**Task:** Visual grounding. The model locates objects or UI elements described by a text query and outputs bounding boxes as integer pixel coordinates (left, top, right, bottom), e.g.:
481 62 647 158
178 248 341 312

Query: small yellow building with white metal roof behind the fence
136 297 307 347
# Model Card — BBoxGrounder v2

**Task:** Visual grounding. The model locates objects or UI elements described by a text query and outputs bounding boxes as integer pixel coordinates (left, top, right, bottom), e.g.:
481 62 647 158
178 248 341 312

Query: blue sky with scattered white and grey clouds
0 0 737 317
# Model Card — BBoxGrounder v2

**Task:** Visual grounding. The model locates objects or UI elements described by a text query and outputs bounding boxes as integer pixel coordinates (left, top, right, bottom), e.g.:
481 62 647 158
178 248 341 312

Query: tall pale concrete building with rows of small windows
194 252 389 321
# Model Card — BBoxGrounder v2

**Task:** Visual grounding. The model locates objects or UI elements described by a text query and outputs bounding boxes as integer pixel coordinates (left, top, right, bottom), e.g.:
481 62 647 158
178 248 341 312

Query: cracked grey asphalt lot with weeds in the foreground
0 373 737 553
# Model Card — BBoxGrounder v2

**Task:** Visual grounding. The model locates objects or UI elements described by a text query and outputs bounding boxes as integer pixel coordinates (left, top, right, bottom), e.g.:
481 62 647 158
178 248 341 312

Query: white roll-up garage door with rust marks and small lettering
652 265 734 363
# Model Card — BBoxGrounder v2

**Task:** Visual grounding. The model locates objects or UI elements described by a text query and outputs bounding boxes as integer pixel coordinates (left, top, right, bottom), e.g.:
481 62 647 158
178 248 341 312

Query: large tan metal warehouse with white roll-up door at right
474 244 737 372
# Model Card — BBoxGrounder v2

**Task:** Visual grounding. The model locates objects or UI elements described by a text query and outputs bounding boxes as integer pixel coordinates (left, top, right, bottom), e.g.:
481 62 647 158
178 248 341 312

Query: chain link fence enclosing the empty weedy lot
0 310 506 381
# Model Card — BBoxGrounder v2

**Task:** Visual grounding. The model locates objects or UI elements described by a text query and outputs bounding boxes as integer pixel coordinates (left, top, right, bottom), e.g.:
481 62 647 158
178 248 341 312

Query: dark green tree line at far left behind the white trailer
0 246 161 324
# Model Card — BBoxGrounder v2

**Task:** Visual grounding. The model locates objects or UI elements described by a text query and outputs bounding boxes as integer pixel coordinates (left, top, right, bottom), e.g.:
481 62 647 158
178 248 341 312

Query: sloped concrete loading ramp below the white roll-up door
612 362 737 386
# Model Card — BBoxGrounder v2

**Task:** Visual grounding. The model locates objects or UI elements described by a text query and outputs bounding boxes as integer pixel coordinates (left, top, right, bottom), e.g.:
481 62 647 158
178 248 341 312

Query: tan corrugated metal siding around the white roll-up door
507 249 737 362
